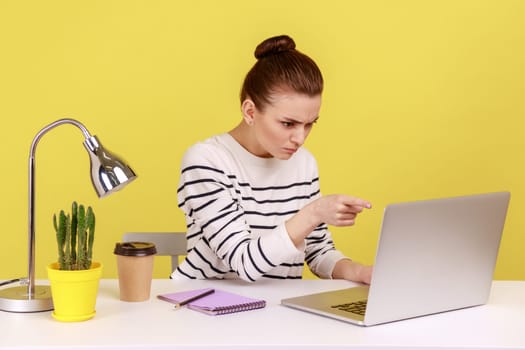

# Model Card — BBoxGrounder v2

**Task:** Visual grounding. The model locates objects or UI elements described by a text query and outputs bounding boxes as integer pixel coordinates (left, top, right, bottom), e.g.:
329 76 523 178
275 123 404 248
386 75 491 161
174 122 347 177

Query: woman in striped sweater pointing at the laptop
171 35 372 283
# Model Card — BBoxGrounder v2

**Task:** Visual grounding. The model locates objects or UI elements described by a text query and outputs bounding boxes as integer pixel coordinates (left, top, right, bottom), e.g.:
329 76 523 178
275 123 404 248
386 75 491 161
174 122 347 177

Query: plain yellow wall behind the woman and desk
0 0 525 279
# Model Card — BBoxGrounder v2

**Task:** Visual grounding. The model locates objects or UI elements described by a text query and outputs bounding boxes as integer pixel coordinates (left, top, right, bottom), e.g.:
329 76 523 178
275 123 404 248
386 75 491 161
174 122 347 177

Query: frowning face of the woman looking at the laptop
245 92 321 160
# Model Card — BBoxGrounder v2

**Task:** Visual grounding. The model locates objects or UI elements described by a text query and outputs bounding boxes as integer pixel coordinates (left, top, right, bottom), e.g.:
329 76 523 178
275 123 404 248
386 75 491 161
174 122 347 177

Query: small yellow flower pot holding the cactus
47 262 102 322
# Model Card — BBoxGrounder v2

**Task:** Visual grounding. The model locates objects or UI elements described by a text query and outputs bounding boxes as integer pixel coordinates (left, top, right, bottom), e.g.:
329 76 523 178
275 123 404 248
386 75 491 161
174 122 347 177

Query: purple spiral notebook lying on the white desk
157 288 266 315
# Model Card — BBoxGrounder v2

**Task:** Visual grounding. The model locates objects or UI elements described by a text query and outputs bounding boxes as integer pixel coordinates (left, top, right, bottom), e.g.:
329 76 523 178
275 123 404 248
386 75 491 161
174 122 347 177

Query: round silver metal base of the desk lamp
0 286 53 312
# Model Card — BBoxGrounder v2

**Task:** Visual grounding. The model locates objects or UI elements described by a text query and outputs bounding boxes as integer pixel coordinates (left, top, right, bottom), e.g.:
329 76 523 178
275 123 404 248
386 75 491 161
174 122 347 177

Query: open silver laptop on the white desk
281 192 510 326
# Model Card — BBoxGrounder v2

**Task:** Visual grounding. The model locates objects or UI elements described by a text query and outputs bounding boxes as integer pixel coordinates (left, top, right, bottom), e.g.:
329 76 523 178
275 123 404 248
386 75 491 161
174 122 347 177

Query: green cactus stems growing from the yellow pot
53 202 95 270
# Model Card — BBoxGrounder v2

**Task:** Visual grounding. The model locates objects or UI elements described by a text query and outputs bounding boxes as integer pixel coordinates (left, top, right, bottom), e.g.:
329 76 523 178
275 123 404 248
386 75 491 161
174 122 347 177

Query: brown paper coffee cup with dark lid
113 242 157 301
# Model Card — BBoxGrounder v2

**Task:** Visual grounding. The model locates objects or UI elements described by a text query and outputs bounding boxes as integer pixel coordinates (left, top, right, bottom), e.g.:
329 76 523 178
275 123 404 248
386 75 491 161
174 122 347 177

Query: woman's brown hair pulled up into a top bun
240 35 323 110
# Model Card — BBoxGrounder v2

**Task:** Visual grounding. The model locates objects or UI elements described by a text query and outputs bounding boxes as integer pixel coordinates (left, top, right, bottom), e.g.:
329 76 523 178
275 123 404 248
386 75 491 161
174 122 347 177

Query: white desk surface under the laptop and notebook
0 280 525 350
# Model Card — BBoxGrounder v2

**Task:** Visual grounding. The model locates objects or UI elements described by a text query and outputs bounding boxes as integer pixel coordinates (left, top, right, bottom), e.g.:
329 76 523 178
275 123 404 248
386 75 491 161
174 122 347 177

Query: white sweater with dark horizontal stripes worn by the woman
171 134 344 282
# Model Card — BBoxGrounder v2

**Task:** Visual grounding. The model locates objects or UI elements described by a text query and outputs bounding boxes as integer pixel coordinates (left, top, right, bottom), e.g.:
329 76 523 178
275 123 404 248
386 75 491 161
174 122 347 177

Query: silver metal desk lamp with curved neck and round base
0 119 136 312
